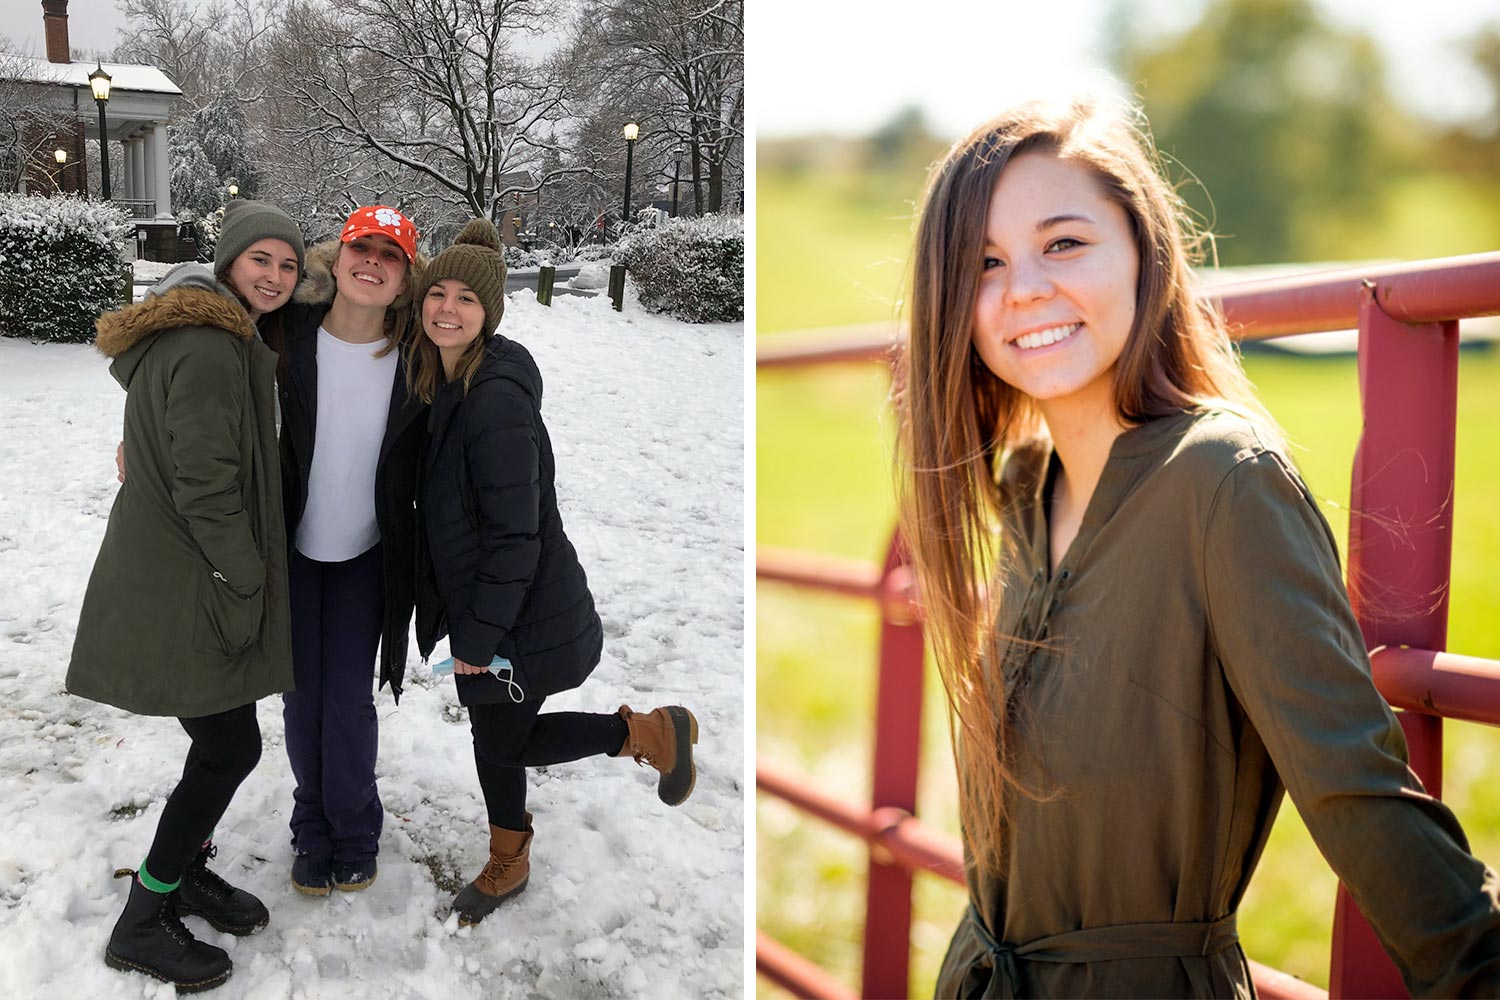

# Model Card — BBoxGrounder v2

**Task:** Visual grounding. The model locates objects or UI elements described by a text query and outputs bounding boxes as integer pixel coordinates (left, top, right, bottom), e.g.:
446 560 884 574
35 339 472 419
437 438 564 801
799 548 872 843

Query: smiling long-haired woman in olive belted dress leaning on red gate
896 100 1500 997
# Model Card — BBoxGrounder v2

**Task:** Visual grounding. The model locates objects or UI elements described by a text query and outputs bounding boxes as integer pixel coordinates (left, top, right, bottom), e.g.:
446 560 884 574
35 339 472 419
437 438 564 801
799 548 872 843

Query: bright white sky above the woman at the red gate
747 0 1500 136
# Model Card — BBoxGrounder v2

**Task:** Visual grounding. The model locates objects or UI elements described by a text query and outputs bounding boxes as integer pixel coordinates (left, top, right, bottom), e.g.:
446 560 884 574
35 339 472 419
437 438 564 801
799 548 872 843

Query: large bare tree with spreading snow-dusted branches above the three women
279 0 582 220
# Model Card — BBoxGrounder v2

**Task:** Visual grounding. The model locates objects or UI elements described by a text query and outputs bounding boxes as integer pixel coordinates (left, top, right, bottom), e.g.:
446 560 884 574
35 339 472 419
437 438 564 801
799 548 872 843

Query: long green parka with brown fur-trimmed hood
68 264 293 718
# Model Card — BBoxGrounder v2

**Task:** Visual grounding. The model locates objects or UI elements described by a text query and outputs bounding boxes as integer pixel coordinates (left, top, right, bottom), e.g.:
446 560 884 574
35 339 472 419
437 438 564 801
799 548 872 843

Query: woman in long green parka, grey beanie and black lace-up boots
68 201 303 993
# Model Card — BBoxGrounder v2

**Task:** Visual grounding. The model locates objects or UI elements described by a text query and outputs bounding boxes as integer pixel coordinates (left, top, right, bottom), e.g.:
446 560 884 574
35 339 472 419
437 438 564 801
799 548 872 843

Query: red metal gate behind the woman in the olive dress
756 253 1500 999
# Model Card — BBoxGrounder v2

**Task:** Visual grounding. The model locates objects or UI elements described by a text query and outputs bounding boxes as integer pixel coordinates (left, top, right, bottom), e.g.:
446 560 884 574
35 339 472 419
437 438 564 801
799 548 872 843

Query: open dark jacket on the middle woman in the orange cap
278 244 428 703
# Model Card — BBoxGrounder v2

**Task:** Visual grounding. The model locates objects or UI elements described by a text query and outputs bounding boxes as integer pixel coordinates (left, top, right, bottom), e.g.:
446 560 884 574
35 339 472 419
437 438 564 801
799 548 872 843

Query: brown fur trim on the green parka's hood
95 264 255 385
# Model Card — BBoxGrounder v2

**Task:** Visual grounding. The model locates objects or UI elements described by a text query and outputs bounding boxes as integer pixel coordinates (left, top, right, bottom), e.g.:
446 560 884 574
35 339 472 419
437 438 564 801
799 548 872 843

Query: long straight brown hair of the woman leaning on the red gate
893 99 1280 871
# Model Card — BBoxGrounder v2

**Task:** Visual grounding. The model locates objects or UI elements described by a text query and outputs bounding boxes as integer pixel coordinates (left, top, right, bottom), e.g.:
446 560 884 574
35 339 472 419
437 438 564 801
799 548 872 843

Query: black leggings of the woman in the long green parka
146 702 261 883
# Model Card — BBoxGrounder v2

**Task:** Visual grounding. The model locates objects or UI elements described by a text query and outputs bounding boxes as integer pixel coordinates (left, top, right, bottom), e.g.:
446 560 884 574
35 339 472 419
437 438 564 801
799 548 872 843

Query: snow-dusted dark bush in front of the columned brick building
0 195 132 342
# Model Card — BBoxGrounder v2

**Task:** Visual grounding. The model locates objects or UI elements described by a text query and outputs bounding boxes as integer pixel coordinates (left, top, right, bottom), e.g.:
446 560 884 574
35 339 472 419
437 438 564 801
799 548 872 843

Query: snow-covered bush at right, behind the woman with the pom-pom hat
615 216 746 322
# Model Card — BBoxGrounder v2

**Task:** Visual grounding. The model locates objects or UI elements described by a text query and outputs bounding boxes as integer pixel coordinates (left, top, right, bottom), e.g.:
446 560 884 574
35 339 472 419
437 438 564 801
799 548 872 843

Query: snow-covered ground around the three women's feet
0 292 744 1000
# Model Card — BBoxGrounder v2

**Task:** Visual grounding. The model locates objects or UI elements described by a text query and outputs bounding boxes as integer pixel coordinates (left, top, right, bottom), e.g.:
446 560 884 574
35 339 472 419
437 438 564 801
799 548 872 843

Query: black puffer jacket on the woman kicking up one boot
417 334 603 705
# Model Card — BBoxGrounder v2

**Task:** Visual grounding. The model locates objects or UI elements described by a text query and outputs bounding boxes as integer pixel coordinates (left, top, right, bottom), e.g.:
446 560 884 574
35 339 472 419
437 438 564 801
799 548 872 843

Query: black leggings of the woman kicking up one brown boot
465 699 630 827
